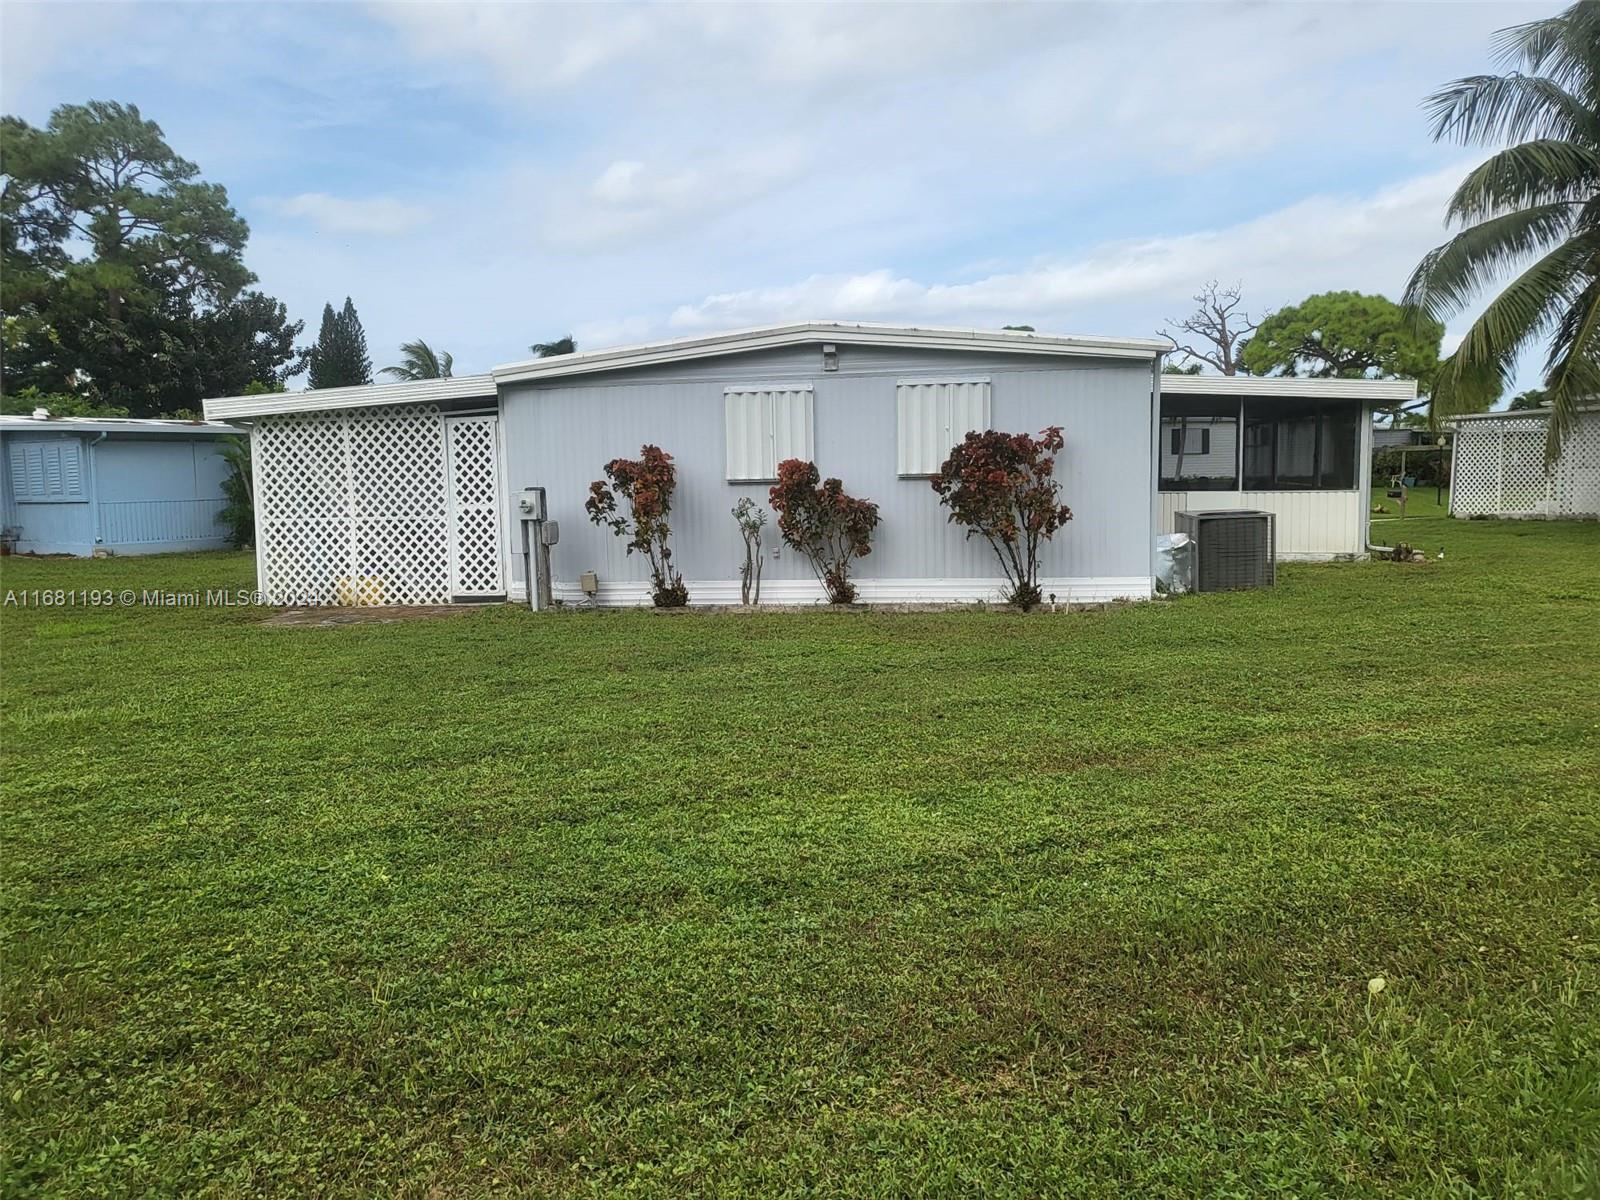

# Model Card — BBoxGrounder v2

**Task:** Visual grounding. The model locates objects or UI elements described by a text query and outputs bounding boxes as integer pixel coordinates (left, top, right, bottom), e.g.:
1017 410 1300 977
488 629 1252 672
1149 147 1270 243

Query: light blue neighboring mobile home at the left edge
0 416 238 555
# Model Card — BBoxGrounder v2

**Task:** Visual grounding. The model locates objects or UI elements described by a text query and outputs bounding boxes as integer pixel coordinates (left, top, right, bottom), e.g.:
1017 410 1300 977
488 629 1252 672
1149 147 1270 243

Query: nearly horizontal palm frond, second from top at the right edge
1422 74 1600 146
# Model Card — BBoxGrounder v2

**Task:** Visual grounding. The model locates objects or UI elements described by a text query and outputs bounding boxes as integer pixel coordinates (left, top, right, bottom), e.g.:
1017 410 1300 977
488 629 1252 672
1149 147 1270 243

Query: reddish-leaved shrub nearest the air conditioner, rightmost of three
933 426 1072 610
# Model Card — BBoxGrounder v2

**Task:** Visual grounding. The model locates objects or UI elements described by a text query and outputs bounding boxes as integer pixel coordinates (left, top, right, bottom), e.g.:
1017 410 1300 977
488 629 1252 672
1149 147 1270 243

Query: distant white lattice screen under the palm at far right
1450 413 1600 517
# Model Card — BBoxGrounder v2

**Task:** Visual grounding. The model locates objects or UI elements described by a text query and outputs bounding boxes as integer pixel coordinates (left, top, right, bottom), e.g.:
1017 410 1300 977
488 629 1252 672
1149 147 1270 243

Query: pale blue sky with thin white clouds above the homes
0 2 1554 384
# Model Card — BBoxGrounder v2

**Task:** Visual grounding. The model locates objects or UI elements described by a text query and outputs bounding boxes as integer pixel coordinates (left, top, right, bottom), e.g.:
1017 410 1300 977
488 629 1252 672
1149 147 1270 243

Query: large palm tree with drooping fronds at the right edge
1405 3 1600 458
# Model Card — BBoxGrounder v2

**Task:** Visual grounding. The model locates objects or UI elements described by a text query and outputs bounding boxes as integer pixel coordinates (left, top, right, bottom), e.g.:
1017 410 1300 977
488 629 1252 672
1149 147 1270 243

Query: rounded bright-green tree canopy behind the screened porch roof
1240 291 1445 392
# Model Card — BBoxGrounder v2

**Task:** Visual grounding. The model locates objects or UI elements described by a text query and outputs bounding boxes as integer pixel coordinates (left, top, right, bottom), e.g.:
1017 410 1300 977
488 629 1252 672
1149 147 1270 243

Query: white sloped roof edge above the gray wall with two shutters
491 322 1170 384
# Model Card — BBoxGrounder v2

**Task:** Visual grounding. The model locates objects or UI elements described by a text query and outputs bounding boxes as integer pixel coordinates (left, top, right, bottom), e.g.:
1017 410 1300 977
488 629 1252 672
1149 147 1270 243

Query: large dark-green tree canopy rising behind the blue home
0 101 302 416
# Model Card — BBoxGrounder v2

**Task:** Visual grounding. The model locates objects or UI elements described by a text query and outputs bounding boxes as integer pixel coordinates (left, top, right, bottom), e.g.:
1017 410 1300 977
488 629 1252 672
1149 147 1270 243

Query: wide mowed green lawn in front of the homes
0 522 1600 1197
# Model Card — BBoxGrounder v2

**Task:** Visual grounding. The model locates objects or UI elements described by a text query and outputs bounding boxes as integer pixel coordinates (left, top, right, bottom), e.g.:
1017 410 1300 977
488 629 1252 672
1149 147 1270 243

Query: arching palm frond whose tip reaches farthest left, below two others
1402 203 1574 322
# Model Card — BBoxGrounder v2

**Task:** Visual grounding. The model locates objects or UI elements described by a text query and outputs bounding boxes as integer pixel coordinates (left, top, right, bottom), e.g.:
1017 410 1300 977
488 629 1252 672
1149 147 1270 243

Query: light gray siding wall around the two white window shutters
501 346 1154 595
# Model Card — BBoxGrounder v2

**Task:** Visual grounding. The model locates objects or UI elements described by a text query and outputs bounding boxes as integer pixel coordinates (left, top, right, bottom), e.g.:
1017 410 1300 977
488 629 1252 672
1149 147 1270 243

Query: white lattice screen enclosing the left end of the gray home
253 405 502 605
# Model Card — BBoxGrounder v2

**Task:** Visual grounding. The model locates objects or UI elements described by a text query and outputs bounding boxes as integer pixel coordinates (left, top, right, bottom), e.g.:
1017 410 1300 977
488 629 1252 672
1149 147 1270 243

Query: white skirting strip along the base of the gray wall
510 574 1155 608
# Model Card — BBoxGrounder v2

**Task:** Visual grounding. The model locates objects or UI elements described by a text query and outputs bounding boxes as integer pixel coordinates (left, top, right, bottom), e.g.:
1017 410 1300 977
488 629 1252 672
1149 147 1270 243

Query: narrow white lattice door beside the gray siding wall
445 416 506 598
